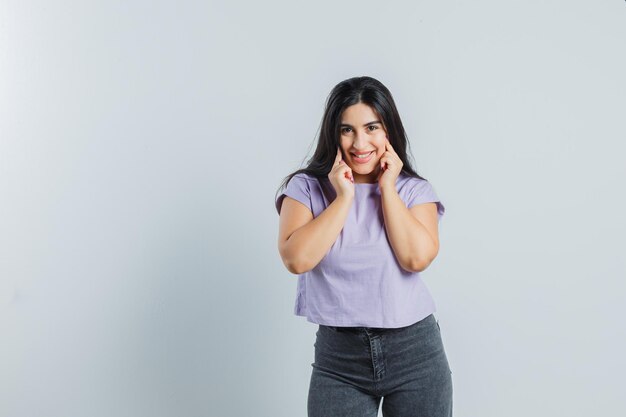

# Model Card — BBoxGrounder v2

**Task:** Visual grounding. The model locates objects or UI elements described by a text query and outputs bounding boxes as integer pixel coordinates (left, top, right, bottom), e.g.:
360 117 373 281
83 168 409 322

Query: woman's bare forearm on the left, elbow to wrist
286 196 353 274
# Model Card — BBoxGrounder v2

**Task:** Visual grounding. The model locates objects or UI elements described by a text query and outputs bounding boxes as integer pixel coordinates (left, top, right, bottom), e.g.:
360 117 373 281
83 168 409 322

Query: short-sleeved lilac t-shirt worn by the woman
276 173 445 328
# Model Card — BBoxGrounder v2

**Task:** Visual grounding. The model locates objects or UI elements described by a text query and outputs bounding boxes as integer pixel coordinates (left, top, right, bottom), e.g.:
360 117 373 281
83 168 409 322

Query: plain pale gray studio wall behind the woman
0 0 626 417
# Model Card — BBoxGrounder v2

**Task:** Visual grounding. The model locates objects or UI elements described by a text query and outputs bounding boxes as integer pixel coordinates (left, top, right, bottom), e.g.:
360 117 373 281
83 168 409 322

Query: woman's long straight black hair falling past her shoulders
276 76 426 202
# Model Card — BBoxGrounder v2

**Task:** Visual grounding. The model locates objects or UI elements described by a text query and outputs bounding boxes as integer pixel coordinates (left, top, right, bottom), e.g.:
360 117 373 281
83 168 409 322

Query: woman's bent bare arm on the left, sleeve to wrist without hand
278 195 353 274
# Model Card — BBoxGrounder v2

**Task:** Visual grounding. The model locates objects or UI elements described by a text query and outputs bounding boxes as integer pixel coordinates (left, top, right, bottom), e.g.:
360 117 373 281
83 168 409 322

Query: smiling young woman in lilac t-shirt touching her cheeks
276 77 452 417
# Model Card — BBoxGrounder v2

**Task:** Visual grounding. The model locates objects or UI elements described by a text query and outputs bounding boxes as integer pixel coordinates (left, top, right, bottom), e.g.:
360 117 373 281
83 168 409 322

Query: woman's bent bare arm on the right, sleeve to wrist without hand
381 187 439 272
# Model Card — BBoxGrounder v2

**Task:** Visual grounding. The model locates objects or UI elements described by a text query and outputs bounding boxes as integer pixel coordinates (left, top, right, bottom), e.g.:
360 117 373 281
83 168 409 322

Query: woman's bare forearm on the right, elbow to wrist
381 187 439 272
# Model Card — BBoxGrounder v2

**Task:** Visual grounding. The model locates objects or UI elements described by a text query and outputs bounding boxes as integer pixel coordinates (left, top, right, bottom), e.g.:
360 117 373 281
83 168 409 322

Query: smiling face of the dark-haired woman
339 103 387 183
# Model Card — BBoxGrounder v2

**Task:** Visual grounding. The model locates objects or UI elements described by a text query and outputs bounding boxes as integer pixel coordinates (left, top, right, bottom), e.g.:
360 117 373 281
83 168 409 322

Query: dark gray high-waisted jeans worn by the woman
307 314 452 417
